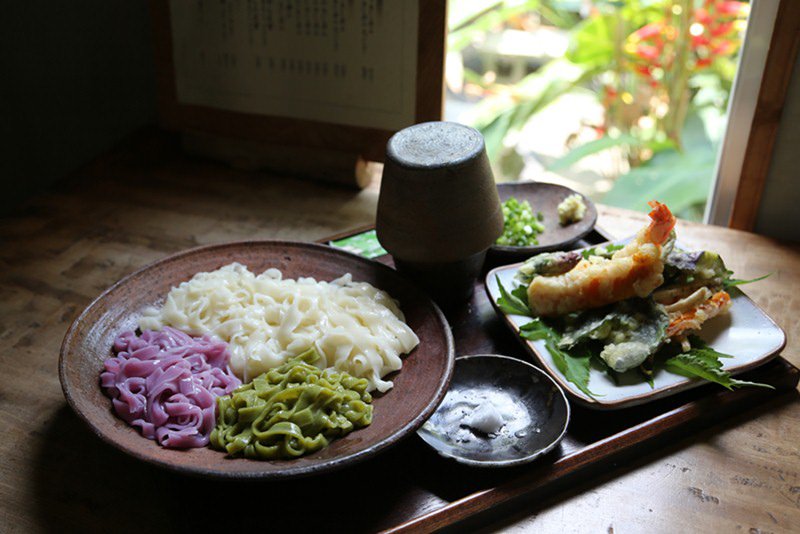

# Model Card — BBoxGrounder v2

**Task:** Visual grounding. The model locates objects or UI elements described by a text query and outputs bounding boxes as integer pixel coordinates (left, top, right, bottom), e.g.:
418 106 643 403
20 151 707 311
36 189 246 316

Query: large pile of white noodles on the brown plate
139 263 419 392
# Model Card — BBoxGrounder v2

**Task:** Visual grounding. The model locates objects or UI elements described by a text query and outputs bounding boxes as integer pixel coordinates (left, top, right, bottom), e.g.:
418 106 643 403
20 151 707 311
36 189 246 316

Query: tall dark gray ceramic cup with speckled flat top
376 122 503 305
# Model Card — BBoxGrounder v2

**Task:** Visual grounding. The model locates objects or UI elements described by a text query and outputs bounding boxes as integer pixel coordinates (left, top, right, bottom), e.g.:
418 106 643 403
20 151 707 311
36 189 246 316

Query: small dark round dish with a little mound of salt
417 354 570 467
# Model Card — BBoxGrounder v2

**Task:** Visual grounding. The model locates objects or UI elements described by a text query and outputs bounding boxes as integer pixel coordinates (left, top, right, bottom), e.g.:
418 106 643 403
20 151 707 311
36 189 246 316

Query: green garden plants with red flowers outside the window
448 0 747 220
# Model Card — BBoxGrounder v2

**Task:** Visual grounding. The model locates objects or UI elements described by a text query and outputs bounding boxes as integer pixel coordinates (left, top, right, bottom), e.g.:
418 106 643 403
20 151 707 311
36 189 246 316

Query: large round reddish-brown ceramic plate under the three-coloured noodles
58 241 454 482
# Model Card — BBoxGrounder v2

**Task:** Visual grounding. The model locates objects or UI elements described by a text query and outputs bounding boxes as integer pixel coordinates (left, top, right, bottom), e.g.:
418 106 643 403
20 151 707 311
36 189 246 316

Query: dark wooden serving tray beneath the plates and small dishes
217 227 800 532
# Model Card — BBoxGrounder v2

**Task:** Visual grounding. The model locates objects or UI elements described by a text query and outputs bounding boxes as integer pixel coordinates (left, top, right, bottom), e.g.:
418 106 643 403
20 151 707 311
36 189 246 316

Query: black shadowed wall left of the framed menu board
0 0 156 215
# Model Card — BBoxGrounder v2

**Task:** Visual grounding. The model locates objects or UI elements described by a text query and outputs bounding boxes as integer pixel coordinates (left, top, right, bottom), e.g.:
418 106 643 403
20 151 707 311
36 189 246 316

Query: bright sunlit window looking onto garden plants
445 0 749 220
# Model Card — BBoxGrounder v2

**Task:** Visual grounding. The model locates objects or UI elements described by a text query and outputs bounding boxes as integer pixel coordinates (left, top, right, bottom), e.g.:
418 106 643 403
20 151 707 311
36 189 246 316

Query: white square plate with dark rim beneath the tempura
486 263 786 410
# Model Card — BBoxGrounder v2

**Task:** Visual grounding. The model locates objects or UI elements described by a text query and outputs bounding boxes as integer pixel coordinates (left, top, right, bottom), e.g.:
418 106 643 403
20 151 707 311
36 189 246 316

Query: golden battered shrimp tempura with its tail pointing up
528 200 675 317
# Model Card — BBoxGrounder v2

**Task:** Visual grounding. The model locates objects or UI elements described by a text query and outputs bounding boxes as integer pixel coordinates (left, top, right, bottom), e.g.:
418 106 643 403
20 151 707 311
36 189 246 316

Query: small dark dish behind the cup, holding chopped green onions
490 182 597 261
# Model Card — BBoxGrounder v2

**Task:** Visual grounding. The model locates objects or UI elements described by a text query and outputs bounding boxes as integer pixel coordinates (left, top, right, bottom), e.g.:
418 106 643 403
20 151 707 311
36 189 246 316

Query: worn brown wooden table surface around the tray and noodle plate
0 132 800 533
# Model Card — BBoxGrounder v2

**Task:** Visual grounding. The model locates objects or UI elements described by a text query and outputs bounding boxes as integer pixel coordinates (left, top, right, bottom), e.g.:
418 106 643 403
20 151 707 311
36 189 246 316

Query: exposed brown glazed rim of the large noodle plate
59 240 455 480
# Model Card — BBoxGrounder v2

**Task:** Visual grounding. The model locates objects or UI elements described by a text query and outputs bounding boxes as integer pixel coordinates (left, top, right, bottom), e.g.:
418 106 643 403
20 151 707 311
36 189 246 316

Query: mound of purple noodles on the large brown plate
100 327 241 449
